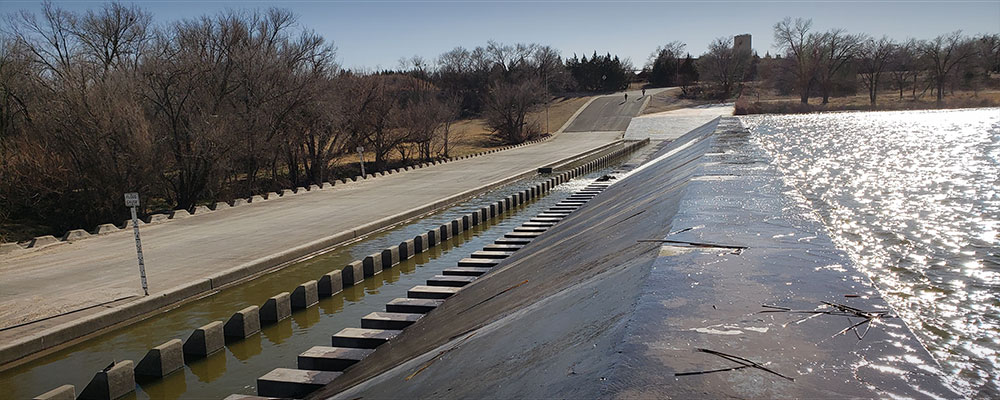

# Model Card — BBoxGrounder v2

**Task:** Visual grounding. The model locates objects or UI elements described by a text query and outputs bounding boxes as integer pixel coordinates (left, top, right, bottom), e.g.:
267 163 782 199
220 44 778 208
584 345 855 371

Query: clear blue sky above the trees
0 0 1000 68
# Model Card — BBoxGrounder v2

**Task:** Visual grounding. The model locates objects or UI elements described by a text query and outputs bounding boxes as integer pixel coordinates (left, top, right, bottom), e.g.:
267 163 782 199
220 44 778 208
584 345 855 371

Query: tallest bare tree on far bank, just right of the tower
774 17 820 104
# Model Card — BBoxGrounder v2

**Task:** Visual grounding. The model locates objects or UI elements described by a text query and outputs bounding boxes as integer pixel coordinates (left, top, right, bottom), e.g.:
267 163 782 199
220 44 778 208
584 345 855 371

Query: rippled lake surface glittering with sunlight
743 108 1000 397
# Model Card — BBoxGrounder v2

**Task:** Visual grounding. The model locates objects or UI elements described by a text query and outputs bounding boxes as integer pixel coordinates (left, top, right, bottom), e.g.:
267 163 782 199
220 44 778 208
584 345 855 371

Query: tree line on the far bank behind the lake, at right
643 18 1000 106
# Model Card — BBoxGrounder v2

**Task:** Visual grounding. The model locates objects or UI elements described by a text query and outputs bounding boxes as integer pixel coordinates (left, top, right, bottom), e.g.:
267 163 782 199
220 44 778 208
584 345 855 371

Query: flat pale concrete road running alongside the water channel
0 133 620 334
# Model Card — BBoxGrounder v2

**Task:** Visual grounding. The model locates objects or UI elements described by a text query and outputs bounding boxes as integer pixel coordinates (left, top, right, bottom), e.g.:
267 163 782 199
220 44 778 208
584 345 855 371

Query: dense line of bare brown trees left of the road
0 3 636 239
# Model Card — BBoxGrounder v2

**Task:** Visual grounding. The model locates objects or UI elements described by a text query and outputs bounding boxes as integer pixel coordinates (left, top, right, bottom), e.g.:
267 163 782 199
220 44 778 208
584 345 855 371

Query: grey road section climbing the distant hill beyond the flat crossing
565 88 667 132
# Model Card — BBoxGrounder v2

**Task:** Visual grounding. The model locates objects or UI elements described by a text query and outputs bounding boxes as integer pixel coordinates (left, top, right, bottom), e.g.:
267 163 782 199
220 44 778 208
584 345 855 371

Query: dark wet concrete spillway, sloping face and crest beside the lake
312 119 958 399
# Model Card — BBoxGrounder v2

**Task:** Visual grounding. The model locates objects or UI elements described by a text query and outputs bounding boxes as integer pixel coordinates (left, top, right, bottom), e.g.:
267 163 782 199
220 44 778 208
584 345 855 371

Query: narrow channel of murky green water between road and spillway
11 143 642 398
